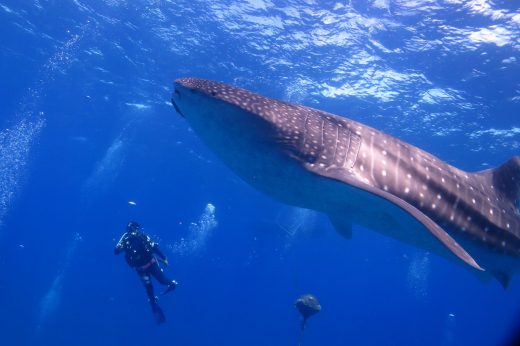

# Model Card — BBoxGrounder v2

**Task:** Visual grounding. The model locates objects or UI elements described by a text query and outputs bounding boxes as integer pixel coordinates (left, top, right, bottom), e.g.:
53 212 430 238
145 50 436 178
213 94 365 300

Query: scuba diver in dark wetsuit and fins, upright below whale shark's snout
114 221 177 324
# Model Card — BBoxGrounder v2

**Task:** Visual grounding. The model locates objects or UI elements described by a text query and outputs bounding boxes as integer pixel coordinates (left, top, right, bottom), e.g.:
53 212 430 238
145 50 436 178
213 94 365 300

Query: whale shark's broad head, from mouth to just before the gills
172 78 330 204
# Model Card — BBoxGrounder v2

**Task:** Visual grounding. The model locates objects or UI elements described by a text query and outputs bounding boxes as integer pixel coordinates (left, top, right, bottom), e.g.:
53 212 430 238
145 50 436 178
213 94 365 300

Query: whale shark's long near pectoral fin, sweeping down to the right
305 164 484 271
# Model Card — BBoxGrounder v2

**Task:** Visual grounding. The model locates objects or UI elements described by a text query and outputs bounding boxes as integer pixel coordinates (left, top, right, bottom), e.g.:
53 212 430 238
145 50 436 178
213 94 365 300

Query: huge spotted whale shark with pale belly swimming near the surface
172 78 520 287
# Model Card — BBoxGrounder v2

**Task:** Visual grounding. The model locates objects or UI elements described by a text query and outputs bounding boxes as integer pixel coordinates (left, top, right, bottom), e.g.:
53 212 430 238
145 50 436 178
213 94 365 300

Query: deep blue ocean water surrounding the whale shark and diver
0 0 520 346
